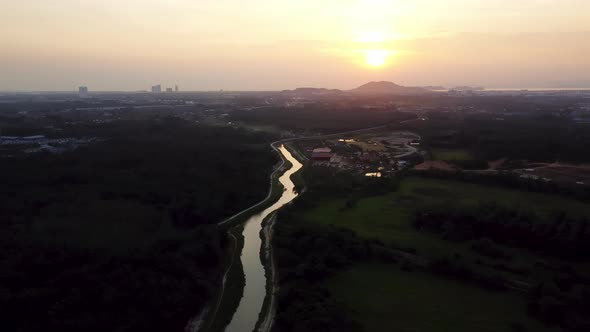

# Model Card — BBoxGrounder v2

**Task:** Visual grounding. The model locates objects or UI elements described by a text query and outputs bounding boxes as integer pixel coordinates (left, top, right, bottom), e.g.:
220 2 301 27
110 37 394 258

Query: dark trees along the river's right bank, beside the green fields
273 219 380 331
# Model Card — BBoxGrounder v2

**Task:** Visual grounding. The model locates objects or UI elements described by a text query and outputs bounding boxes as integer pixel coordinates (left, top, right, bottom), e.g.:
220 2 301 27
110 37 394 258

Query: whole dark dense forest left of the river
0 117 278 332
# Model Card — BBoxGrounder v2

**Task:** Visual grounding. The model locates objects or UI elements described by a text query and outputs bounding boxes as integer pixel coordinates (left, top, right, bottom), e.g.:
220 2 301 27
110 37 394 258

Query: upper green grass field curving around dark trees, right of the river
303 177 590 255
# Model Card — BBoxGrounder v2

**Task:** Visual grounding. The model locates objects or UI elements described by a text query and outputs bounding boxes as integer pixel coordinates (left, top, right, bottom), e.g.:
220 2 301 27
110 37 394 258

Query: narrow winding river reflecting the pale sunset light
225 145 303 332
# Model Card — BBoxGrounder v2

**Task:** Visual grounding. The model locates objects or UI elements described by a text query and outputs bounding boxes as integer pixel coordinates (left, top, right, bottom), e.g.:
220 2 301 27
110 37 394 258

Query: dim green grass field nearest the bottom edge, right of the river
325 263 551 332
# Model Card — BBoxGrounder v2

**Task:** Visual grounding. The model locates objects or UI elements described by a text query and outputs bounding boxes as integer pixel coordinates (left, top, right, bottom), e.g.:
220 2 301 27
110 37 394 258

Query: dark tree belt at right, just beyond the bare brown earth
404 115 590 162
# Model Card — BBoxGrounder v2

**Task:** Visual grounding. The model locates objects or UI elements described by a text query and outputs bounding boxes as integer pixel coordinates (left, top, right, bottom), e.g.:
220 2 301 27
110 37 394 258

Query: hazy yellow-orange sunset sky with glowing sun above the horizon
0 0 590 91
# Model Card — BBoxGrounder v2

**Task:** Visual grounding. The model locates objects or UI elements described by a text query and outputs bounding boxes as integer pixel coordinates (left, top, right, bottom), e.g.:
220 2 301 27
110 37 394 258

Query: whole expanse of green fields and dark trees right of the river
275 168 590 332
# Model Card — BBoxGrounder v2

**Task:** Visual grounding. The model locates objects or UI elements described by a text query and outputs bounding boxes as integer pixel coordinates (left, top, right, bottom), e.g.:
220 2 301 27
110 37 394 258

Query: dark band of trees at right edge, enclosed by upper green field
413 204 590 260
